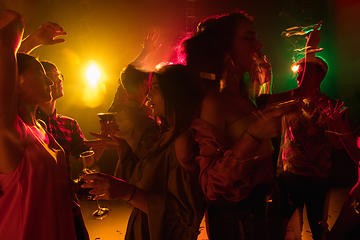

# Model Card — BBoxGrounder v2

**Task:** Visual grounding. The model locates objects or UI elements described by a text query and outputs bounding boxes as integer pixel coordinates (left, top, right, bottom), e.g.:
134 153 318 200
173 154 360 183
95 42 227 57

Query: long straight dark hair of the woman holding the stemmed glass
151 64 201 152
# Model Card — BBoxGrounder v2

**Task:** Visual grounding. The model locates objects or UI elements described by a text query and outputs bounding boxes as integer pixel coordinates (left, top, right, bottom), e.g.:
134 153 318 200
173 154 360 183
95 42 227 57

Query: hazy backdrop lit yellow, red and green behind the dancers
0 0 360 184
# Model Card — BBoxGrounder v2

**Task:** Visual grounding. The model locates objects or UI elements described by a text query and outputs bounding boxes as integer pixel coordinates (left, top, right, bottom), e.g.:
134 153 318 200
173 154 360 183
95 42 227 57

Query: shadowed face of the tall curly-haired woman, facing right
231 20 263 75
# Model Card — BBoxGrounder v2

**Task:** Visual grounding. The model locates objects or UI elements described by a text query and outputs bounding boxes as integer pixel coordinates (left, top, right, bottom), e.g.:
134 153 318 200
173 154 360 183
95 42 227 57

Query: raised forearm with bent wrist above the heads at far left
19 22 67 53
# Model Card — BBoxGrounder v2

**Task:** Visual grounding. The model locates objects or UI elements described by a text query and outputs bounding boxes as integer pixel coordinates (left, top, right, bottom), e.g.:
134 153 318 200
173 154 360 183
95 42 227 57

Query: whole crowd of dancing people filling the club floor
0 8 360 240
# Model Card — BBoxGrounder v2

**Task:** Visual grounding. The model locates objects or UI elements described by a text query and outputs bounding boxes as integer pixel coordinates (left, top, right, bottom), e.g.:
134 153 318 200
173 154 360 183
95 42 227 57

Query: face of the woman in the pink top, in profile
19 59 53 104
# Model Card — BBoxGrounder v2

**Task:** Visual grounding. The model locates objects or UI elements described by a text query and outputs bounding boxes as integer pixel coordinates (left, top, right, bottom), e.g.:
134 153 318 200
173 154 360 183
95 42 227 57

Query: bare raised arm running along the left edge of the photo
0 11 24 173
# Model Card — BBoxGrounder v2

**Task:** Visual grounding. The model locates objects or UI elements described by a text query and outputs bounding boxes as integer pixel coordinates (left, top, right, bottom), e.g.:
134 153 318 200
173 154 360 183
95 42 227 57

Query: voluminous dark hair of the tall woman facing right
180 11 252 95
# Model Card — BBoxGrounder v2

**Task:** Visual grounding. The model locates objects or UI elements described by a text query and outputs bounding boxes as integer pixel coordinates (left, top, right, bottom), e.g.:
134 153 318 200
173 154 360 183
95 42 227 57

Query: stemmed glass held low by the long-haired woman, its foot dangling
80 150 110 220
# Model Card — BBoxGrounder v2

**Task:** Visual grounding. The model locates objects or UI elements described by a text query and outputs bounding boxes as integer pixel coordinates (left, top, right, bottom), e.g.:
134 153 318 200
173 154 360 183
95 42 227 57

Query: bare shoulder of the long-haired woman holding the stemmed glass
175 131 198 172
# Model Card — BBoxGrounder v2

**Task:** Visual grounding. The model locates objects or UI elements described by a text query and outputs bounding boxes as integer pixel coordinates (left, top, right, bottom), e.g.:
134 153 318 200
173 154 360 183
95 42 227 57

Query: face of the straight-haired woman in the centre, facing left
148 75 165 117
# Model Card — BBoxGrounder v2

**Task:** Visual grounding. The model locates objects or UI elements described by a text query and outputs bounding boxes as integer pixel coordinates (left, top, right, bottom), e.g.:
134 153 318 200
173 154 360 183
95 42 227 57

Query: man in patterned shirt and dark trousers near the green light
278 56 342 239
